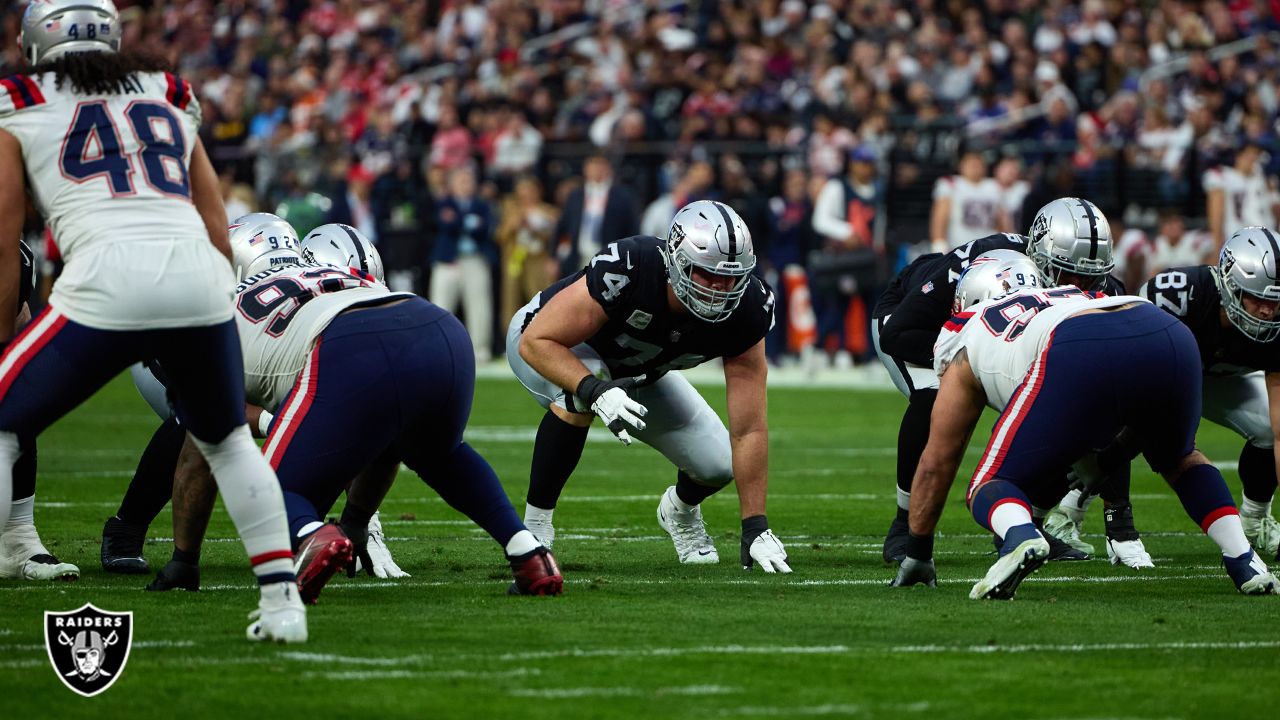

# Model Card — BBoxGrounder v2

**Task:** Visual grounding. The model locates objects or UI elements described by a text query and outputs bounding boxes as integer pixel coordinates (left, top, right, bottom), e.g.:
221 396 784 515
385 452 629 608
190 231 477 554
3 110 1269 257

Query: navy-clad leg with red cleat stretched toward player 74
396 309 564 594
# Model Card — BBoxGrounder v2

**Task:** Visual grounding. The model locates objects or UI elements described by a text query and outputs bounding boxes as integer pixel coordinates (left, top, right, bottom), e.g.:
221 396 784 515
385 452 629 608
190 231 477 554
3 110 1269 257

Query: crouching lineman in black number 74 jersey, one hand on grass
507 200 791 573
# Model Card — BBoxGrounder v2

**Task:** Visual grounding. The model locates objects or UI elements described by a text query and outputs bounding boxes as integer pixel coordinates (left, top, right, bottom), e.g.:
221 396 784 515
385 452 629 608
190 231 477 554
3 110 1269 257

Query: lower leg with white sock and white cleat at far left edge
0 436 79 580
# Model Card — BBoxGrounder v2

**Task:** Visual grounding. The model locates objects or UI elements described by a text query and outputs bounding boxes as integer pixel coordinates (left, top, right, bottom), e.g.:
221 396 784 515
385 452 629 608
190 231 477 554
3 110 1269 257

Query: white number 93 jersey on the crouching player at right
933 287 1147 411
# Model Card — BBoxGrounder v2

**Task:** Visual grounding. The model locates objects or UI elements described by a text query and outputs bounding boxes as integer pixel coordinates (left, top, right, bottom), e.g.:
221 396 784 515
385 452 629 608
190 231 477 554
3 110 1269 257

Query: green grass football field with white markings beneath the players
0 371 1280 720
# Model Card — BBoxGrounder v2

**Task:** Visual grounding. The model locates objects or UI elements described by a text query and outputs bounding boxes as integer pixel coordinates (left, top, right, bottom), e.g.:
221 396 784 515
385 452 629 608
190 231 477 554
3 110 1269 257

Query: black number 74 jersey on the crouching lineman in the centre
525 236 773 383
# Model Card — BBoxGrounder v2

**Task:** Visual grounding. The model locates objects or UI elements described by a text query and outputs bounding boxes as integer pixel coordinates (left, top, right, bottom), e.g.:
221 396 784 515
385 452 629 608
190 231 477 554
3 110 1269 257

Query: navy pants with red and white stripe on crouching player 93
968 302 1201 507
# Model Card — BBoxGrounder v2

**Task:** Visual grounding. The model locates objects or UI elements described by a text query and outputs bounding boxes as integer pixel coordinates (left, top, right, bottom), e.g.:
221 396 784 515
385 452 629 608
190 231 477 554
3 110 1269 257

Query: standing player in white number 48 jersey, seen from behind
0 0 307 642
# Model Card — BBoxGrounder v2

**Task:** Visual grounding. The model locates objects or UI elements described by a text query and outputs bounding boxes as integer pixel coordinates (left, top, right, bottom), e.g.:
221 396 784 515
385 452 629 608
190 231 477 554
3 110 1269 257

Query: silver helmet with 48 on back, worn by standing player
18 0 123 65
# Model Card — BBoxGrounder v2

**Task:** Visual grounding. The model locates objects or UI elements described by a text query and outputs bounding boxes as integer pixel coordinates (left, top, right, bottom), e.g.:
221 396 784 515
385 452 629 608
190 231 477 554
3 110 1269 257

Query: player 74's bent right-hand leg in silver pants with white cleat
631 373 733 564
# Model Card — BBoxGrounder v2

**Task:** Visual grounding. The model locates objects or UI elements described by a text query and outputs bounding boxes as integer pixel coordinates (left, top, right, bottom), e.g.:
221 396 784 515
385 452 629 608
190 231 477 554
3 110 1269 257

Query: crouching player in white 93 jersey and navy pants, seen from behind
893 254 1280 600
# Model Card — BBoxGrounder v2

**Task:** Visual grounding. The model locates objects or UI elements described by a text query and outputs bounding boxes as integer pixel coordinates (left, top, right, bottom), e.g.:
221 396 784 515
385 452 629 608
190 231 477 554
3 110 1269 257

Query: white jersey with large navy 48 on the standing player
0 73 234 329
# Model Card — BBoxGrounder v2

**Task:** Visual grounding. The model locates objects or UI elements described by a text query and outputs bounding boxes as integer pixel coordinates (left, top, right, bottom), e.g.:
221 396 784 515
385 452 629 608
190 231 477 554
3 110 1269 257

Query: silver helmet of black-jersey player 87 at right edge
1217 227 1280 342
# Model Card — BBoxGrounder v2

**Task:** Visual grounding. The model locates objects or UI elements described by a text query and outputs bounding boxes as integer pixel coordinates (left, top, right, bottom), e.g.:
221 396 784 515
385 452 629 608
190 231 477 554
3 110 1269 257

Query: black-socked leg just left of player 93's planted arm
872 318 938 565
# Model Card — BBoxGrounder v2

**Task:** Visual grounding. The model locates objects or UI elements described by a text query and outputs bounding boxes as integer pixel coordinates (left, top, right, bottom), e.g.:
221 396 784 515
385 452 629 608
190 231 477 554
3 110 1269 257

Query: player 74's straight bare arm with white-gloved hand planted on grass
724 340 791 573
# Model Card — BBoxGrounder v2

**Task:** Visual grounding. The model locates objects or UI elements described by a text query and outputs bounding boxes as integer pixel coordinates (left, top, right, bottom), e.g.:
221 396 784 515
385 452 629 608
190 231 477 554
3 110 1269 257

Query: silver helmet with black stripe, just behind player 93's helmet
1027 197 1116 290
